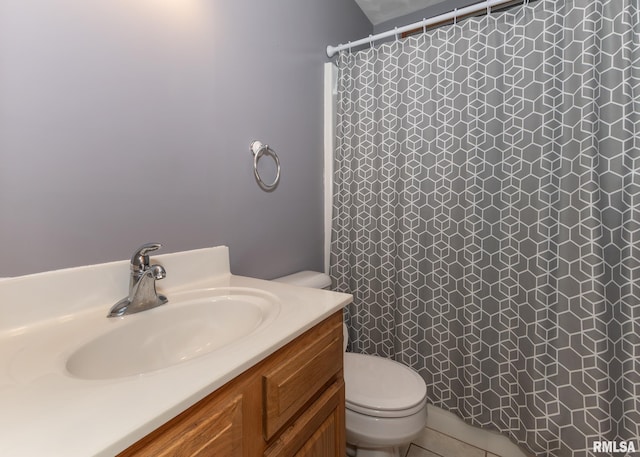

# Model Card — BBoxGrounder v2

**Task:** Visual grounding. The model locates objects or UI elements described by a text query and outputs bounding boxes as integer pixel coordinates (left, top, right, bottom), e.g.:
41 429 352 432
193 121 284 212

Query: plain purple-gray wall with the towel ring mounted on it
0 0 372 278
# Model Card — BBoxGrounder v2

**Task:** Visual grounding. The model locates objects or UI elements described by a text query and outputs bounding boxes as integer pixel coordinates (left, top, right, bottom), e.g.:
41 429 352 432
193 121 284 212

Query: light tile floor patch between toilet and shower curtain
403 428 509 457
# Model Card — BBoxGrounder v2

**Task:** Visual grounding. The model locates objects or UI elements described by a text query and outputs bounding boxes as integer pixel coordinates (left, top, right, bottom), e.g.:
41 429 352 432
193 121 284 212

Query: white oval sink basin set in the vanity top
66 288 280 379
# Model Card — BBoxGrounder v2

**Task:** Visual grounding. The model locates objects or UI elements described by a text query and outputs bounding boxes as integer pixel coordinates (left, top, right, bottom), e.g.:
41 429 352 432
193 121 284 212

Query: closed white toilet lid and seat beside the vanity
344 352 427 417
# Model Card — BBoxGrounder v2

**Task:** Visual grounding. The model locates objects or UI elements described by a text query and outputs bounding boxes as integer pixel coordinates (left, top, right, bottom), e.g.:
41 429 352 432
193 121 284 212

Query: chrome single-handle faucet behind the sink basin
107 243 169 317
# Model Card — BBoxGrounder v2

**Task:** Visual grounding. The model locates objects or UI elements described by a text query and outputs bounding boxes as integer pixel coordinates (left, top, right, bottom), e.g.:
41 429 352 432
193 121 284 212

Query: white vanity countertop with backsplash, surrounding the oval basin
0 248 351 457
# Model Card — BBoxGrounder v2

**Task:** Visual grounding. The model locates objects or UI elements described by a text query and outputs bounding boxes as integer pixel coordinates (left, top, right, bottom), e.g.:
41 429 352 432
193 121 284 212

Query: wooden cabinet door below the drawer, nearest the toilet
265 378 346 457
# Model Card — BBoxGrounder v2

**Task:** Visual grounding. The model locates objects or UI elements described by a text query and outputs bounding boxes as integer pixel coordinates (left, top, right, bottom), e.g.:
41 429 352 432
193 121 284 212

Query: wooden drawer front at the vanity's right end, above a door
262 313 343 441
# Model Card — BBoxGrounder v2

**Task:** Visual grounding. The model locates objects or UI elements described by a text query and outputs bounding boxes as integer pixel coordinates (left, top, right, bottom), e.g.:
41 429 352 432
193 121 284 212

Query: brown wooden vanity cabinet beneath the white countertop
119 311 346 457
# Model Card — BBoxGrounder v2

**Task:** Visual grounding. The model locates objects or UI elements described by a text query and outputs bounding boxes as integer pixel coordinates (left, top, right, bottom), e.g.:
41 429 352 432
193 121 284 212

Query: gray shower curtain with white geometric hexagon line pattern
331 0 640 457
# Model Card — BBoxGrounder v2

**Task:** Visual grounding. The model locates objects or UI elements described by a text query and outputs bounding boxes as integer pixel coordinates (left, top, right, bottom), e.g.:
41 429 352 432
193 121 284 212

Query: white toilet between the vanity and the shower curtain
274 271 427 457
